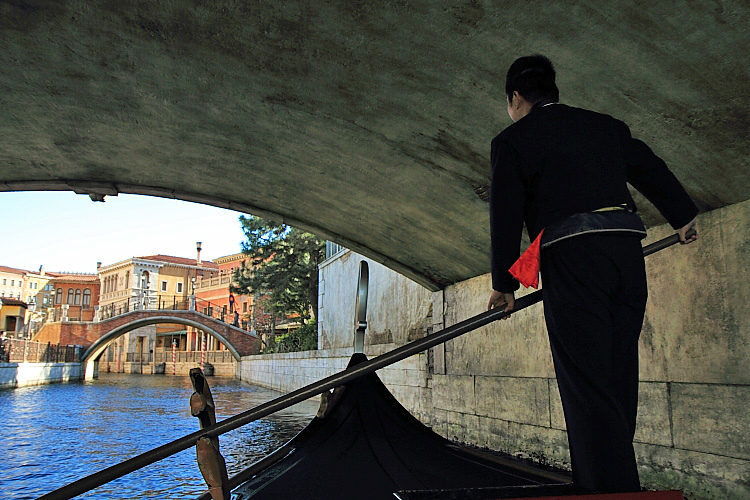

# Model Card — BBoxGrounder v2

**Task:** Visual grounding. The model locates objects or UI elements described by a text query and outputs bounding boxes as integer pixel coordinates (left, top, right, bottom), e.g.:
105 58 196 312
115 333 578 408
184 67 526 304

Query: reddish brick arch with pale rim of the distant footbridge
81 309 261 379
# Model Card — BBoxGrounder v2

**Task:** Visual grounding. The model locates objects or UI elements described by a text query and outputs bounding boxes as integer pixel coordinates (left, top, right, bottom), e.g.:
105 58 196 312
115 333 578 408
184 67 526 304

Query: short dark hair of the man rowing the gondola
505 54 560 104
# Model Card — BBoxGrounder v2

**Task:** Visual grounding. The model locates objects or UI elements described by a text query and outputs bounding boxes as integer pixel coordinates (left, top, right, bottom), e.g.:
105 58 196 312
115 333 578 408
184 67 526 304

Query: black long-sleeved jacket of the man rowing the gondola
490 101 698 292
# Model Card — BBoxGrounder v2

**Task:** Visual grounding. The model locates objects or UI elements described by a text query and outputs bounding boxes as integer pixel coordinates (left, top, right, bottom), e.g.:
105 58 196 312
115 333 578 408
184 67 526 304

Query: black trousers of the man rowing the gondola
541 234 648 492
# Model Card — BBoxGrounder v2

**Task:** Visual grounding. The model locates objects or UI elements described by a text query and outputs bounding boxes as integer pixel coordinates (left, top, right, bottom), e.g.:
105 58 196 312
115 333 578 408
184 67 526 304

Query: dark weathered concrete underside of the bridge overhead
0 0 750 289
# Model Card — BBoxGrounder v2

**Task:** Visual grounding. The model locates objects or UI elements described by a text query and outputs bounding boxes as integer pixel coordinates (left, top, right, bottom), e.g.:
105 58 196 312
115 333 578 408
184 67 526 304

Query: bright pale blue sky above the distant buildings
0 191 250 273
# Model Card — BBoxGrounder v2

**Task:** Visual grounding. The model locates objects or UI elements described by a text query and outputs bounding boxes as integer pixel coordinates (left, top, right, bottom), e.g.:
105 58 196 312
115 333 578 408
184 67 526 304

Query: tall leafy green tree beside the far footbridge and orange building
231 216 325 323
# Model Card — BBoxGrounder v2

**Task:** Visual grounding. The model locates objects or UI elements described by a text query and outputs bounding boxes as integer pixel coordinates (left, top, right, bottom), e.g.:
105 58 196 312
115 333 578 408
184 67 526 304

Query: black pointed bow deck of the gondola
233 354 565 500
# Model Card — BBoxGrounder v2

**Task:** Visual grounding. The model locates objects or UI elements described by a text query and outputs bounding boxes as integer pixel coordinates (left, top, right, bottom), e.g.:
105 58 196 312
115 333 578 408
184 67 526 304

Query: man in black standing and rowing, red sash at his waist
488 56 698 492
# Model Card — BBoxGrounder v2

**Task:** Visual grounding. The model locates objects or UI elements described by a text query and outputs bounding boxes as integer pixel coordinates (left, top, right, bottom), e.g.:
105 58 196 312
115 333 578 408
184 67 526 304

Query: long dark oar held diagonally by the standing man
30 229 691 500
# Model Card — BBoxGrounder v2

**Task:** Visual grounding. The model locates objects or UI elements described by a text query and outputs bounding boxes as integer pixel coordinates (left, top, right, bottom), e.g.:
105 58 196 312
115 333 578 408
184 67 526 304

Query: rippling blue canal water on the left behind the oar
0 374 318 499
